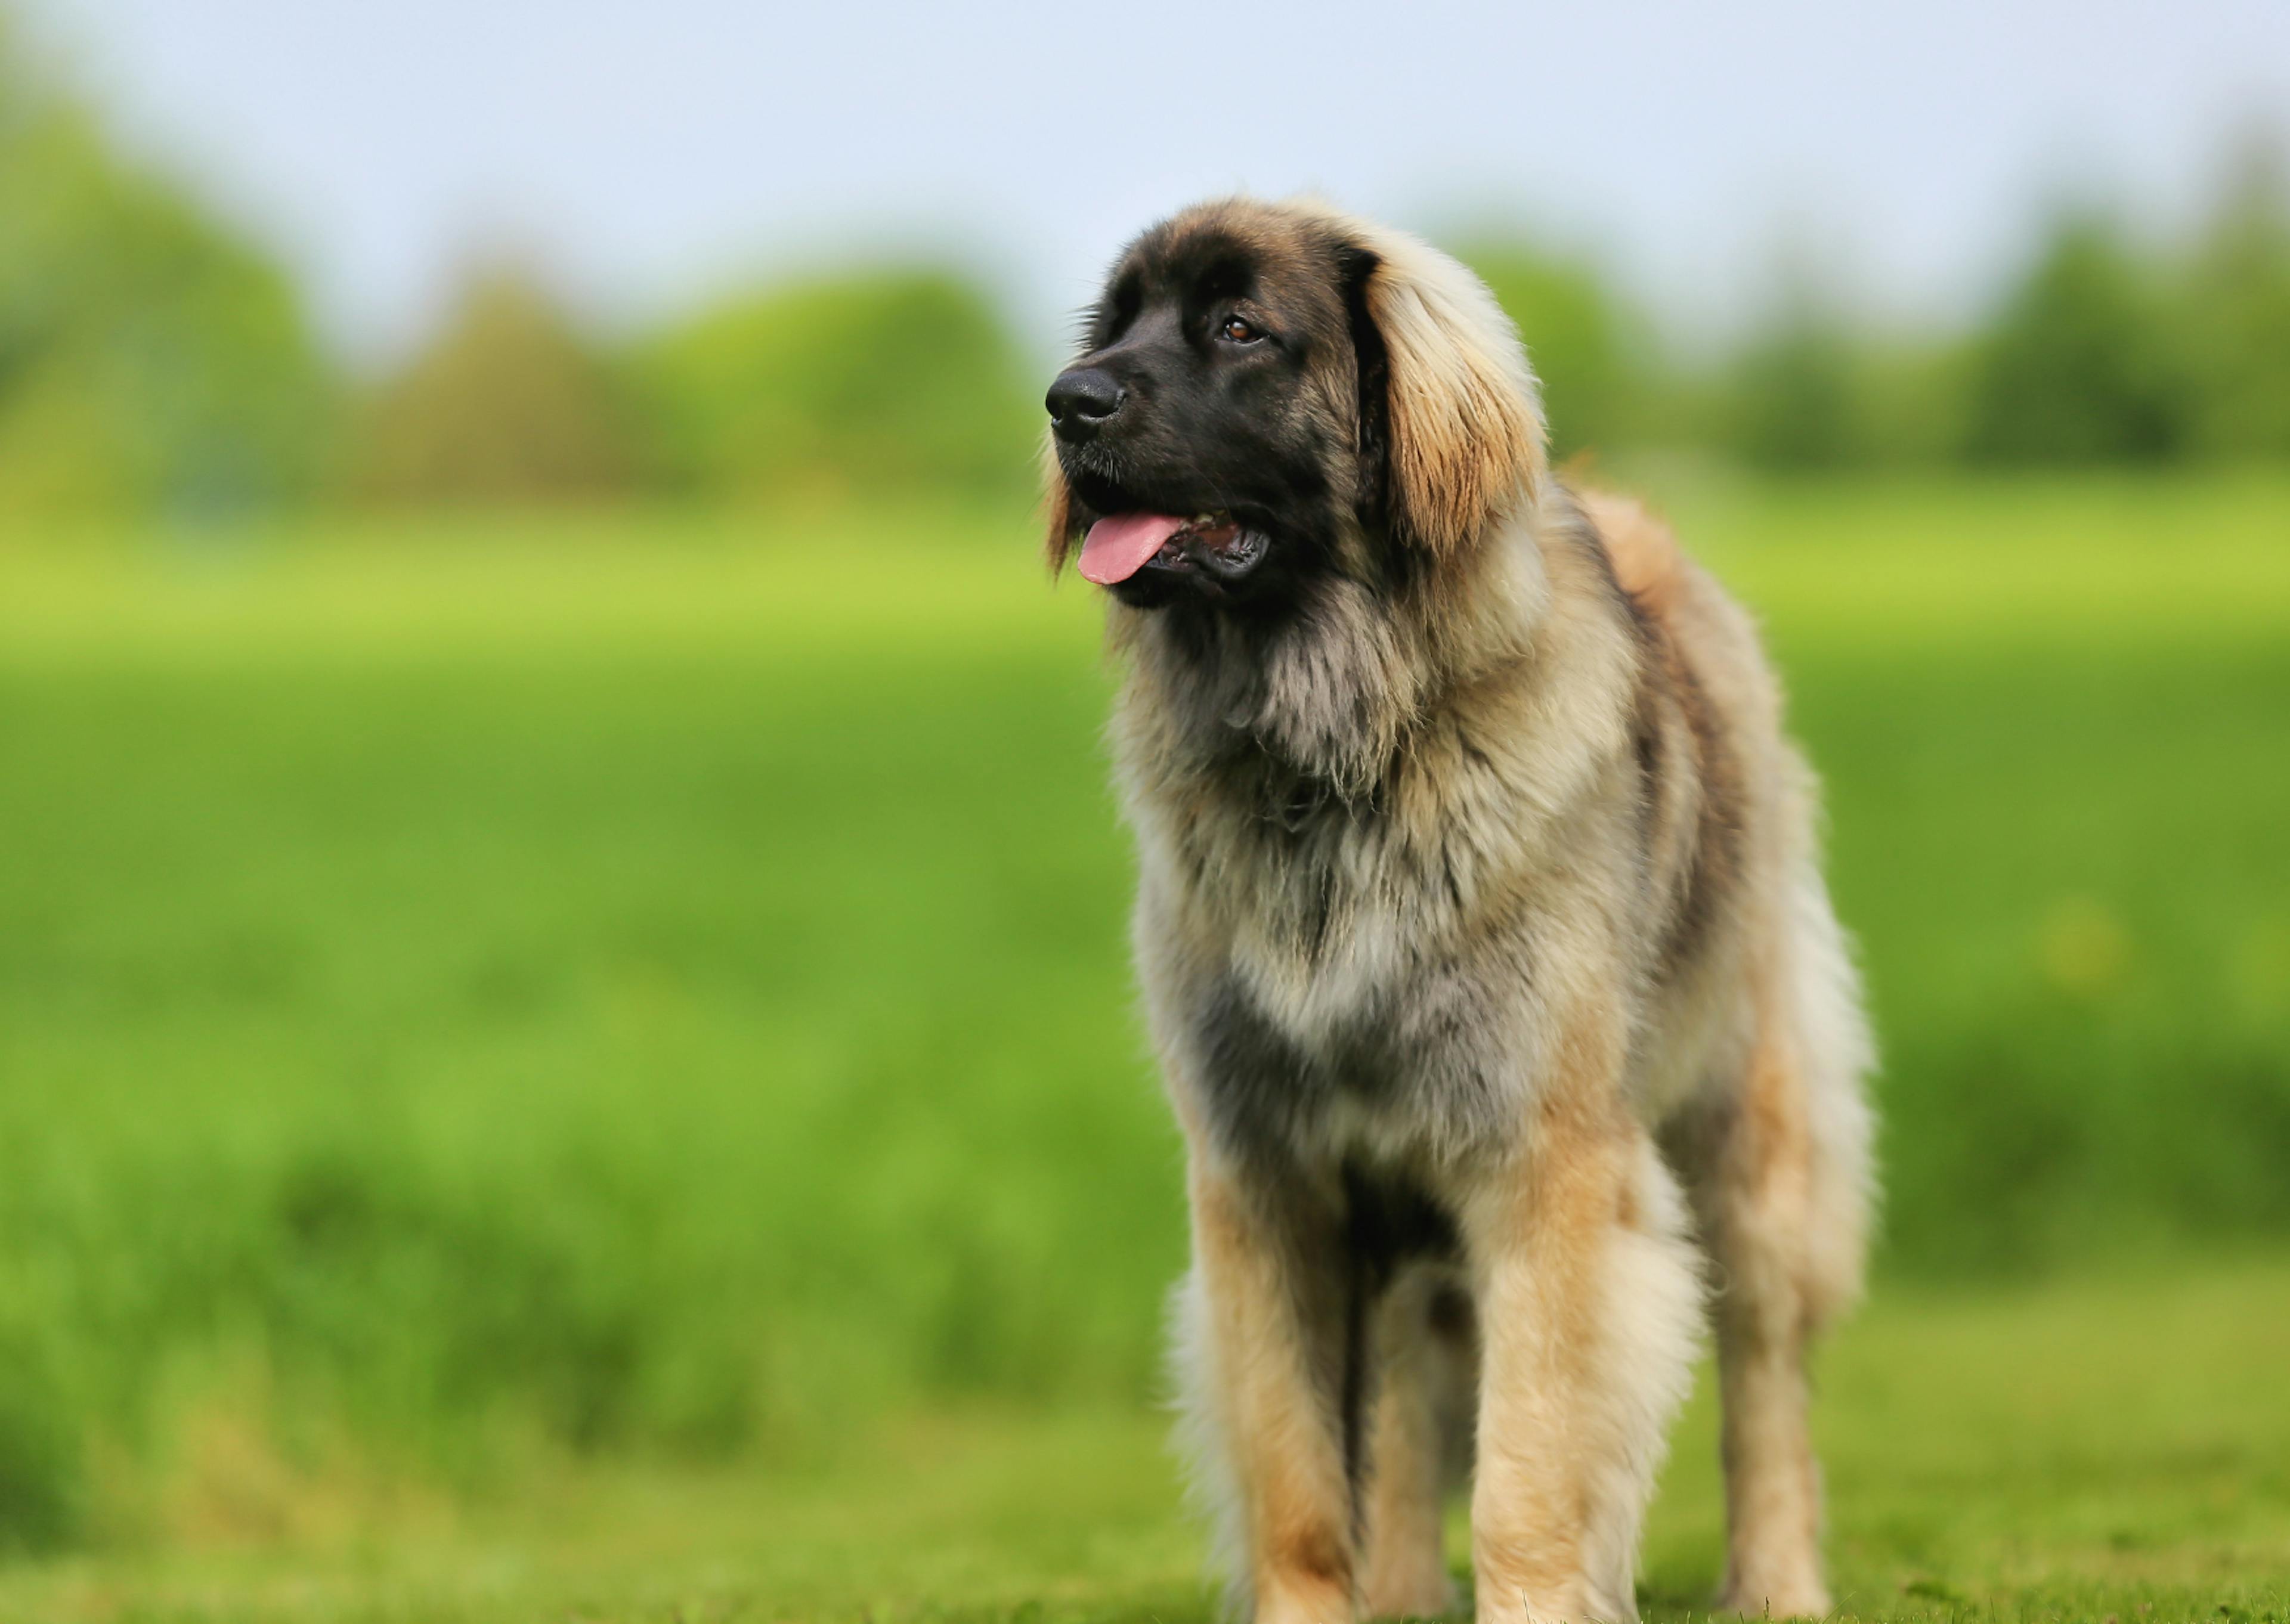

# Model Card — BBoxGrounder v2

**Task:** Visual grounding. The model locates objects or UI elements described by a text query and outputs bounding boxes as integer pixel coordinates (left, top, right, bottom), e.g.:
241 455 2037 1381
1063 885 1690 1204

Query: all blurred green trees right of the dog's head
1459 140 2290 472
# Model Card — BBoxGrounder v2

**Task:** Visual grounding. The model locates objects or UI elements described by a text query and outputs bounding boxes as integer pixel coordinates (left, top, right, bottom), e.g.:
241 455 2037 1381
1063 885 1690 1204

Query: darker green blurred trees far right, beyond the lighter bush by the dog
1701 142 2290 470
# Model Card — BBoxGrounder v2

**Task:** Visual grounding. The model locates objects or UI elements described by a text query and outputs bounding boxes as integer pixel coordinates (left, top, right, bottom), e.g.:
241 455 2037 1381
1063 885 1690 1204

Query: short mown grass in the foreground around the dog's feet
0 1265 2290 1624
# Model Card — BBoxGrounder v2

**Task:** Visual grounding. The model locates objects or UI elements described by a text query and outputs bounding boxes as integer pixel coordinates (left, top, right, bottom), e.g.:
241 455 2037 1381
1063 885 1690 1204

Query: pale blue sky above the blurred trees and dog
18 0 2290 351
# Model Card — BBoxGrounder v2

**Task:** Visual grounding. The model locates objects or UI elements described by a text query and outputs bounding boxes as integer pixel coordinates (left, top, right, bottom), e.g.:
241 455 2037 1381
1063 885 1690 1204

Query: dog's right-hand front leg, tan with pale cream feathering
1463 1030 1701 1624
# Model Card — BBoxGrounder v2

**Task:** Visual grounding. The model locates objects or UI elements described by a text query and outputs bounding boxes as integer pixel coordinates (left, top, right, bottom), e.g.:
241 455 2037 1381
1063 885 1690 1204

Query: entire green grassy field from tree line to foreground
0 481 2290 1619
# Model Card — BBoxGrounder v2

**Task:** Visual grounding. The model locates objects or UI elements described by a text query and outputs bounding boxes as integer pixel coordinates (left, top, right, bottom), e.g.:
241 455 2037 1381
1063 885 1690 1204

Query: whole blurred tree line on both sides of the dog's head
0 1 2290 515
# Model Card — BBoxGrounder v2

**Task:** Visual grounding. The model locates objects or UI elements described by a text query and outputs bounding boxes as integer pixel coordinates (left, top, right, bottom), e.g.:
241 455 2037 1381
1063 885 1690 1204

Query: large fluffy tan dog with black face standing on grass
1049 202 1868 1624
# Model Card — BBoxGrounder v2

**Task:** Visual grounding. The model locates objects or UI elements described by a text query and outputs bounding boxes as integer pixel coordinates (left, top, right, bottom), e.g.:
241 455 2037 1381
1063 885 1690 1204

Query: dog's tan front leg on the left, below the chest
1186 1140 1353 1624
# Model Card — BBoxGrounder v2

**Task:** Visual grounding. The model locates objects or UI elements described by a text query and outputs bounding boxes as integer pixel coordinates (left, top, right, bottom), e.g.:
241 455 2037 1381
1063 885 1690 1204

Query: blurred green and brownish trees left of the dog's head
0 14 1039 517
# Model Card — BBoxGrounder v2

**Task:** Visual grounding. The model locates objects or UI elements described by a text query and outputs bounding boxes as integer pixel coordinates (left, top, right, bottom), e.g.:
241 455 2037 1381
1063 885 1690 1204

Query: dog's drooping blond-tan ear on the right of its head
1339 222 1548 554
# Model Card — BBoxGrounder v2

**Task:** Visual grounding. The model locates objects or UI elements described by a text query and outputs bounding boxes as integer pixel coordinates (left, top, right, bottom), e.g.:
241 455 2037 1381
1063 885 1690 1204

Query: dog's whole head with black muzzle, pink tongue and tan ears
1044 199 1543 616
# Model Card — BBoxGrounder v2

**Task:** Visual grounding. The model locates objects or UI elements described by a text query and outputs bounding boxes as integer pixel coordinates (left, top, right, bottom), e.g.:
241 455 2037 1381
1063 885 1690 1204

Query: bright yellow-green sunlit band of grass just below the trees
0 474 2290 662
